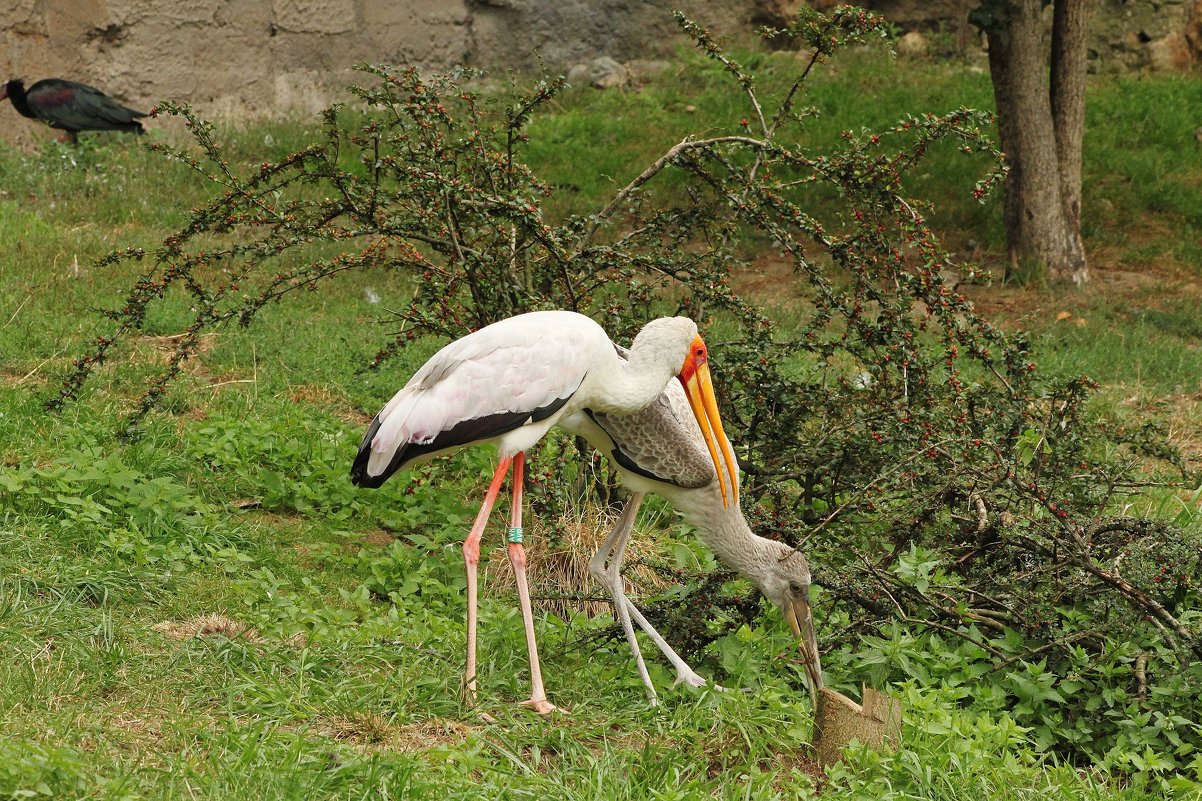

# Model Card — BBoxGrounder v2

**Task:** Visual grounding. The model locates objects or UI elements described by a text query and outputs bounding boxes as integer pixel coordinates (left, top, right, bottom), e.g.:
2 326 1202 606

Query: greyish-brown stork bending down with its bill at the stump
559 348 822 711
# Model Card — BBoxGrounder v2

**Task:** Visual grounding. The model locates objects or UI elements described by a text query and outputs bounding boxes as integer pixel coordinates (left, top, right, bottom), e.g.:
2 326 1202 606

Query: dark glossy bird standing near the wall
0 78 145 142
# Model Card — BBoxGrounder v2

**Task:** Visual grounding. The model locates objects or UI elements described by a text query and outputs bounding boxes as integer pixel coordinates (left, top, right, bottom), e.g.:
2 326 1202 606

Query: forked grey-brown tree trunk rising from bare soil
975 0 1089 284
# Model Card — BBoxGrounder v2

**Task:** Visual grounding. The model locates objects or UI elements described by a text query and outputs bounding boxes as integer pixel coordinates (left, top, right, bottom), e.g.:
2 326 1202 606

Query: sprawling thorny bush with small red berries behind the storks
52 7 1202 769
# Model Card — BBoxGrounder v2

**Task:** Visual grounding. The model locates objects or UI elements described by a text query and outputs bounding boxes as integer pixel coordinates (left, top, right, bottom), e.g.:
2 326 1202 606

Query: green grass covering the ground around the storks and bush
0 46 1202 801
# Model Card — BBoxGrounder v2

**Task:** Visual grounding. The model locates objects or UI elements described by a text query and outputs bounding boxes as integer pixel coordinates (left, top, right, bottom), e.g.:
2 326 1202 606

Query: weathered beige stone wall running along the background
0 0 1202 144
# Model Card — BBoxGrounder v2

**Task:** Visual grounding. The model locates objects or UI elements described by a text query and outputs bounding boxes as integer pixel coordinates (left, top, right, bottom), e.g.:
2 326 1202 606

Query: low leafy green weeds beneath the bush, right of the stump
849 610 1202 793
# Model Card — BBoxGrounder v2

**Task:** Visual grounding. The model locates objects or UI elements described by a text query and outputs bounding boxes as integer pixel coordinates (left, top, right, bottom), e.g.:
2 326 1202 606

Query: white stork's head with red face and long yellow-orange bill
630 318 739 508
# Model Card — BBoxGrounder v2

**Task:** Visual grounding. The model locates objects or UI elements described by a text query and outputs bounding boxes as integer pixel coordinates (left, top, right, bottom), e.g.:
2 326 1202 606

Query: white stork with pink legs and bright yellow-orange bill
351 312 738 714
